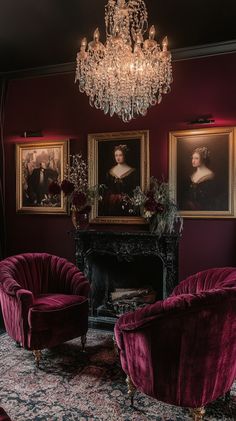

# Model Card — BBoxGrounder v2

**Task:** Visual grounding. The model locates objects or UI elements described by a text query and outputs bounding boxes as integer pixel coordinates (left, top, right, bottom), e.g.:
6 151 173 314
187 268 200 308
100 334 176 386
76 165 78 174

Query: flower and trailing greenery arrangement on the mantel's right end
123 177 183 236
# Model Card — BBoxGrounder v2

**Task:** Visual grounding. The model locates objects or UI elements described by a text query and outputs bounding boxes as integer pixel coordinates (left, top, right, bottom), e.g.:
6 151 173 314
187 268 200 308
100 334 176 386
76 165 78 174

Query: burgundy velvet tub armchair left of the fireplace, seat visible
0 253 90 364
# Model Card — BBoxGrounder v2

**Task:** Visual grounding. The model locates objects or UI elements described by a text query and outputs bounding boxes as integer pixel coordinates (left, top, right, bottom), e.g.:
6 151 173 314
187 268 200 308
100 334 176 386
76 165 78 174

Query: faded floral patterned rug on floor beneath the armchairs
0 330 236 421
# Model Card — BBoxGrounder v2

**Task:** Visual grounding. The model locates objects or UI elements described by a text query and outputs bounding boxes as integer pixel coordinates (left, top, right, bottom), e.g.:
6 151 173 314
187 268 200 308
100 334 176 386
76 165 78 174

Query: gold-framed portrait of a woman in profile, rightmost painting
169 127 236 218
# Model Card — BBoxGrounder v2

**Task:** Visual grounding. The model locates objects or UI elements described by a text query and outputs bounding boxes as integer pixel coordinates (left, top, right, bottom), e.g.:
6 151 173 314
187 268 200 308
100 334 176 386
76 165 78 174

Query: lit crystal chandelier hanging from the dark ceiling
75 0 172 122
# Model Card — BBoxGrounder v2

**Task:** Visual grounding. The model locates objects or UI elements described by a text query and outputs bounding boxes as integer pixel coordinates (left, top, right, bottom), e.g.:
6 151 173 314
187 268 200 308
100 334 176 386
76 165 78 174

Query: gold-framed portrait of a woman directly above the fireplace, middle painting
88 130 150 224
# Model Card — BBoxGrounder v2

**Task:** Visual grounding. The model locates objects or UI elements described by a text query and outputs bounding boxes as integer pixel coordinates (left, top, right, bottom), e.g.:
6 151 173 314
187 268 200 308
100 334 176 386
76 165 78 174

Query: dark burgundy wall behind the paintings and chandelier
5 54 236 279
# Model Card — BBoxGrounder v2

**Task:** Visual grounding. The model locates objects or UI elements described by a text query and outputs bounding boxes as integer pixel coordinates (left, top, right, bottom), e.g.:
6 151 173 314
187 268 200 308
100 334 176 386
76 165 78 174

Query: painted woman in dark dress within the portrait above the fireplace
99 144 140 216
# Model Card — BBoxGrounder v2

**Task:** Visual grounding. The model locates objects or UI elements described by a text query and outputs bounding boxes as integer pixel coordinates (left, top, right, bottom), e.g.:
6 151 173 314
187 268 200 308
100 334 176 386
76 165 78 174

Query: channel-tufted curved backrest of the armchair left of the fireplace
0 253 83 296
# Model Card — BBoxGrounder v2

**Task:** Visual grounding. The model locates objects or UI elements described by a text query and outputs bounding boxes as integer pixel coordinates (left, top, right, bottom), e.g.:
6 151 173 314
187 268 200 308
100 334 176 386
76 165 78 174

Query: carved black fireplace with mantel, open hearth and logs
73 230 179 324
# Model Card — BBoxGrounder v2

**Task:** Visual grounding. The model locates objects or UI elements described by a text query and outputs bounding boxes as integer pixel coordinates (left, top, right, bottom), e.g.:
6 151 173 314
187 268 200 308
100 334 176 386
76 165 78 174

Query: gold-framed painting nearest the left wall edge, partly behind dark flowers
16 140 69 214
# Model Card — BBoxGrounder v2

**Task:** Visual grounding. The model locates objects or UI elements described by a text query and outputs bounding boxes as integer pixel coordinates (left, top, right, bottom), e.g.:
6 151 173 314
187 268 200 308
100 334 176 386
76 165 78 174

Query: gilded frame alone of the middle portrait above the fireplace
88 130 150 224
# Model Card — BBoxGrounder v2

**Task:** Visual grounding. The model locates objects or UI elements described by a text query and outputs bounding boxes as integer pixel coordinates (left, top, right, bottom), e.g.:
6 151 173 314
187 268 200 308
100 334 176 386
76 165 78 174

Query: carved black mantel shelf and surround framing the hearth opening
72 229 179 298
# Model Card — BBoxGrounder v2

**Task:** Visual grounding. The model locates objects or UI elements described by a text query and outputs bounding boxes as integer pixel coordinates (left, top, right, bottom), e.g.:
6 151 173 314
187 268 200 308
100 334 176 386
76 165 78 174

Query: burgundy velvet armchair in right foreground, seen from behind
115 268 236 420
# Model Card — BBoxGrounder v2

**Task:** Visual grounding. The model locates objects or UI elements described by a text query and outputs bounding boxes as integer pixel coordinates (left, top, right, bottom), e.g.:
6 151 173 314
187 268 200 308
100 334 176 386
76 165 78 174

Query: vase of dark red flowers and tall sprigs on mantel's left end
49 153 102 229
